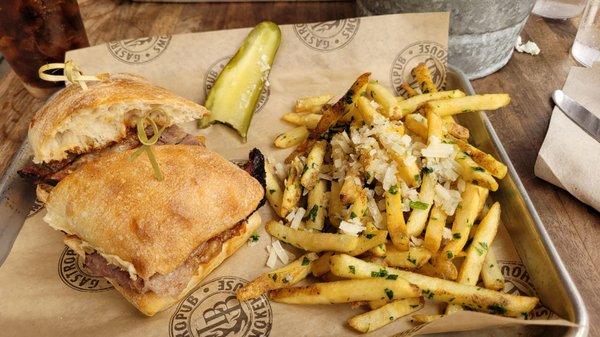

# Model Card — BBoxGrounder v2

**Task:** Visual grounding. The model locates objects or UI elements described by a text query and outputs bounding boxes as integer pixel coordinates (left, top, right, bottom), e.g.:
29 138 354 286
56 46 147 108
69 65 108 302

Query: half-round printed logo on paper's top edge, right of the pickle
294 18 360 52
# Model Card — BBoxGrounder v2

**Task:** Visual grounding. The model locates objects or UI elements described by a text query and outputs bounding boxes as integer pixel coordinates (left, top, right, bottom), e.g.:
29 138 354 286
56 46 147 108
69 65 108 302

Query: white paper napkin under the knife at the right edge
534 63 600 211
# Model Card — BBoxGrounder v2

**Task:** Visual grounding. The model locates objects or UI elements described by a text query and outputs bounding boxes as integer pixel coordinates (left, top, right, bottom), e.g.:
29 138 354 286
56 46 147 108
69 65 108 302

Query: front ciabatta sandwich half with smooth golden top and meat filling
44 145 264 316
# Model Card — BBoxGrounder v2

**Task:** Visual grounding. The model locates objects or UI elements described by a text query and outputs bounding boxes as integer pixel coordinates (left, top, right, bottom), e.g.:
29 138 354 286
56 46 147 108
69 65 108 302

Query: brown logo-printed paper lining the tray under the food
0 13 568 337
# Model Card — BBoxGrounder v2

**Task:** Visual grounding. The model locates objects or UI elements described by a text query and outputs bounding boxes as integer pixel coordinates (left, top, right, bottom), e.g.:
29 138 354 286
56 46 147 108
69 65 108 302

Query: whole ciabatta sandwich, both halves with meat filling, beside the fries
20 74 265 316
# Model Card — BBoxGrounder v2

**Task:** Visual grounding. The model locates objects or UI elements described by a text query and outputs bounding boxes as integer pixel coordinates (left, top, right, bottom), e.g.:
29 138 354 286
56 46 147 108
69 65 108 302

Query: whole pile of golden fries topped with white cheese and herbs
239 71 538 332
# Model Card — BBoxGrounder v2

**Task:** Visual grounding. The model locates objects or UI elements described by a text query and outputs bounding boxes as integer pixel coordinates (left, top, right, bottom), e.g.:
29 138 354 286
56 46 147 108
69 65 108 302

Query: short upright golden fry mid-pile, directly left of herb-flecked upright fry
385 185 410 251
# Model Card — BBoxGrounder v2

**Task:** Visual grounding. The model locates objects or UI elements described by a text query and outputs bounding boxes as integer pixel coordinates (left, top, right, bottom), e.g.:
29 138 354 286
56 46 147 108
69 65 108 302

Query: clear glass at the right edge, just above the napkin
571 0 600 67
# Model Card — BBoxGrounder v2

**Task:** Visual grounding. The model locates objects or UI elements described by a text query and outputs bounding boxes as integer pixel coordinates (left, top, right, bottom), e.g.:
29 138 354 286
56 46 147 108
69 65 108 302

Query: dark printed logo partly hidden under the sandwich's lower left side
58 247 113 292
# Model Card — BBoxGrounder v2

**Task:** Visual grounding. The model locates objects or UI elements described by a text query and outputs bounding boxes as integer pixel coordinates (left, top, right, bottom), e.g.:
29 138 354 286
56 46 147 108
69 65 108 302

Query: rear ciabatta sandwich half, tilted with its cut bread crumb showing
19 74 208 202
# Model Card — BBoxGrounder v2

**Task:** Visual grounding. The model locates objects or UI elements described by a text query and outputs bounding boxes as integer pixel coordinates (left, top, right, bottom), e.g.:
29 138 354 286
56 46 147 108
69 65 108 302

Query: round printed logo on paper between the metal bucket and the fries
390 41 448 95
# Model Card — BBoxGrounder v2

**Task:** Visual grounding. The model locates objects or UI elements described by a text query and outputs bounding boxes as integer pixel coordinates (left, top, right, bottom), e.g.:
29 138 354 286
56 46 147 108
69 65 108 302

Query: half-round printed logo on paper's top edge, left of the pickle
106 36 171 64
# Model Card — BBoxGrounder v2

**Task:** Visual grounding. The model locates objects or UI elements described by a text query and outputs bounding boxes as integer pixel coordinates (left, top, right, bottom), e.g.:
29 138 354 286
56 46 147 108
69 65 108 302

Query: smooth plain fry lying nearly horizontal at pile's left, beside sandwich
265 221 359 253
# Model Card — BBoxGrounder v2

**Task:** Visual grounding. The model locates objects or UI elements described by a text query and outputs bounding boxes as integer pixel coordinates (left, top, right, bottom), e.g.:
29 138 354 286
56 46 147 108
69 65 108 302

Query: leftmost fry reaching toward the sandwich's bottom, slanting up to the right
236 253 318 301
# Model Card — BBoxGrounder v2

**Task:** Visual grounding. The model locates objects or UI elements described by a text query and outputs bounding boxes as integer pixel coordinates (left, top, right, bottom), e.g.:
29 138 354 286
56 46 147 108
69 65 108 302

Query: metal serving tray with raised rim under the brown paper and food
0 66 589 337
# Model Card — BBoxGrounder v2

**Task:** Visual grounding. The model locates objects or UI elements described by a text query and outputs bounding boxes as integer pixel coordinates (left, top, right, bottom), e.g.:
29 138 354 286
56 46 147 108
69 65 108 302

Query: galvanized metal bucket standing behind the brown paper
356 0 535 79
